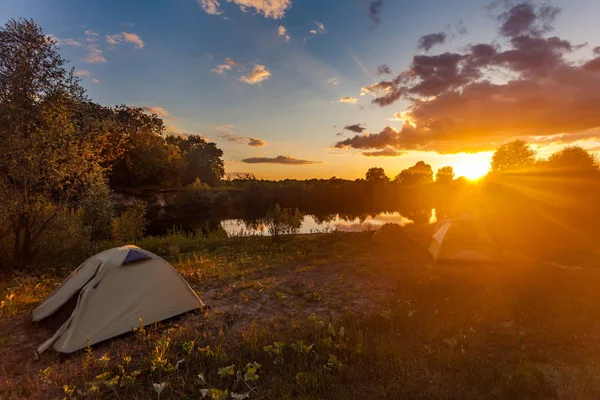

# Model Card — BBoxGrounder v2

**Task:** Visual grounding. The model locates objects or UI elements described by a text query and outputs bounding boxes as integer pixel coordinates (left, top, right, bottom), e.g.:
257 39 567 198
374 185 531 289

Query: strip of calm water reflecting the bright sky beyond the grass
221 210 437 236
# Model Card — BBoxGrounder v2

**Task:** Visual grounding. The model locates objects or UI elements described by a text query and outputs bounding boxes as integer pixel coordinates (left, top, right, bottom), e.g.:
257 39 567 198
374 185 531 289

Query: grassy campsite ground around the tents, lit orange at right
0 227 600 399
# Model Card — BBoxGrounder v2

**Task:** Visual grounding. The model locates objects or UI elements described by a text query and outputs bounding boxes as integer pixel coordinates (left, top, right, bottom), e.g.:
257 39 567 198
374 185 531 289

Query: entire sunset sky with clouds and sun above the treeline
0 0 600 179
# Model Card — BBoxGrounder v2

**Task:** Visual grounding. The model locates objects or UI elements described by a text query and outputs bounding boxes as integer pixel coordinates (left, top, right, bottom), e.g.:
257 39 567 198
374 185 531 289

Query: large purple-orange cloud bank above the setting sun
335 3 600 153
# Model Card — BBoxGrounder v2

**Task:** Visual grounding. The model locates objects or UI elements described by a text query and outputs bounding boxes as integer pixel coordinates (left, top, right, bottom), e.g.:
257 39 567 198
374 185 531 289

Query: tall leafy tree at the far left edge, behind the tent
0 19 103 267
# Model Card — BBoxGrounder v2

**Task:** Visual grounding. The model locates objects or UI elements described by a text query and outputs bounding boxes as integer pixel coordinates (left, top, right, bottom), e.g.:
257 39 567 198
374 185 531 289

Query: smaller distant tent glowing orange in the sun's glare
429 215 500 262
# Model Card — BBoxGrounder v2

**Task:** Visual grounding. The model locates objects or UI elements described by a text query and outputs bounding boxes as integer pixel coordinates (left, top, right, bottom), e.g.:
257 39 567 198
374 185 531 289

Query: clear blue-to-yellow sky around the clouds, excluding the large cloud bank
0 0 600 178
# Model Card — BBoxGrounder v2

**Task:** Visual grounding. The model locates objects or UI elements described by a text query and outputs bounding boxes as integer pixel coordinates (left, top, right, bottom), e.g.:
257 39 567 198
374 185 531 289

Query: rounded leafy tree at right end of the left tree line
167 135 225 186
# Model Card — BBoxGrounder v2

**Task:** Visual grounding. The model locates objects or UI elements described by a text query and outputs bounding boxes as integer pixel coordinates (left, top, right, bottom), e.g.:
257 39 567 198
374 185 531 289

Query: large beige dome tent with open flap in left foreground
32 246 204 354
